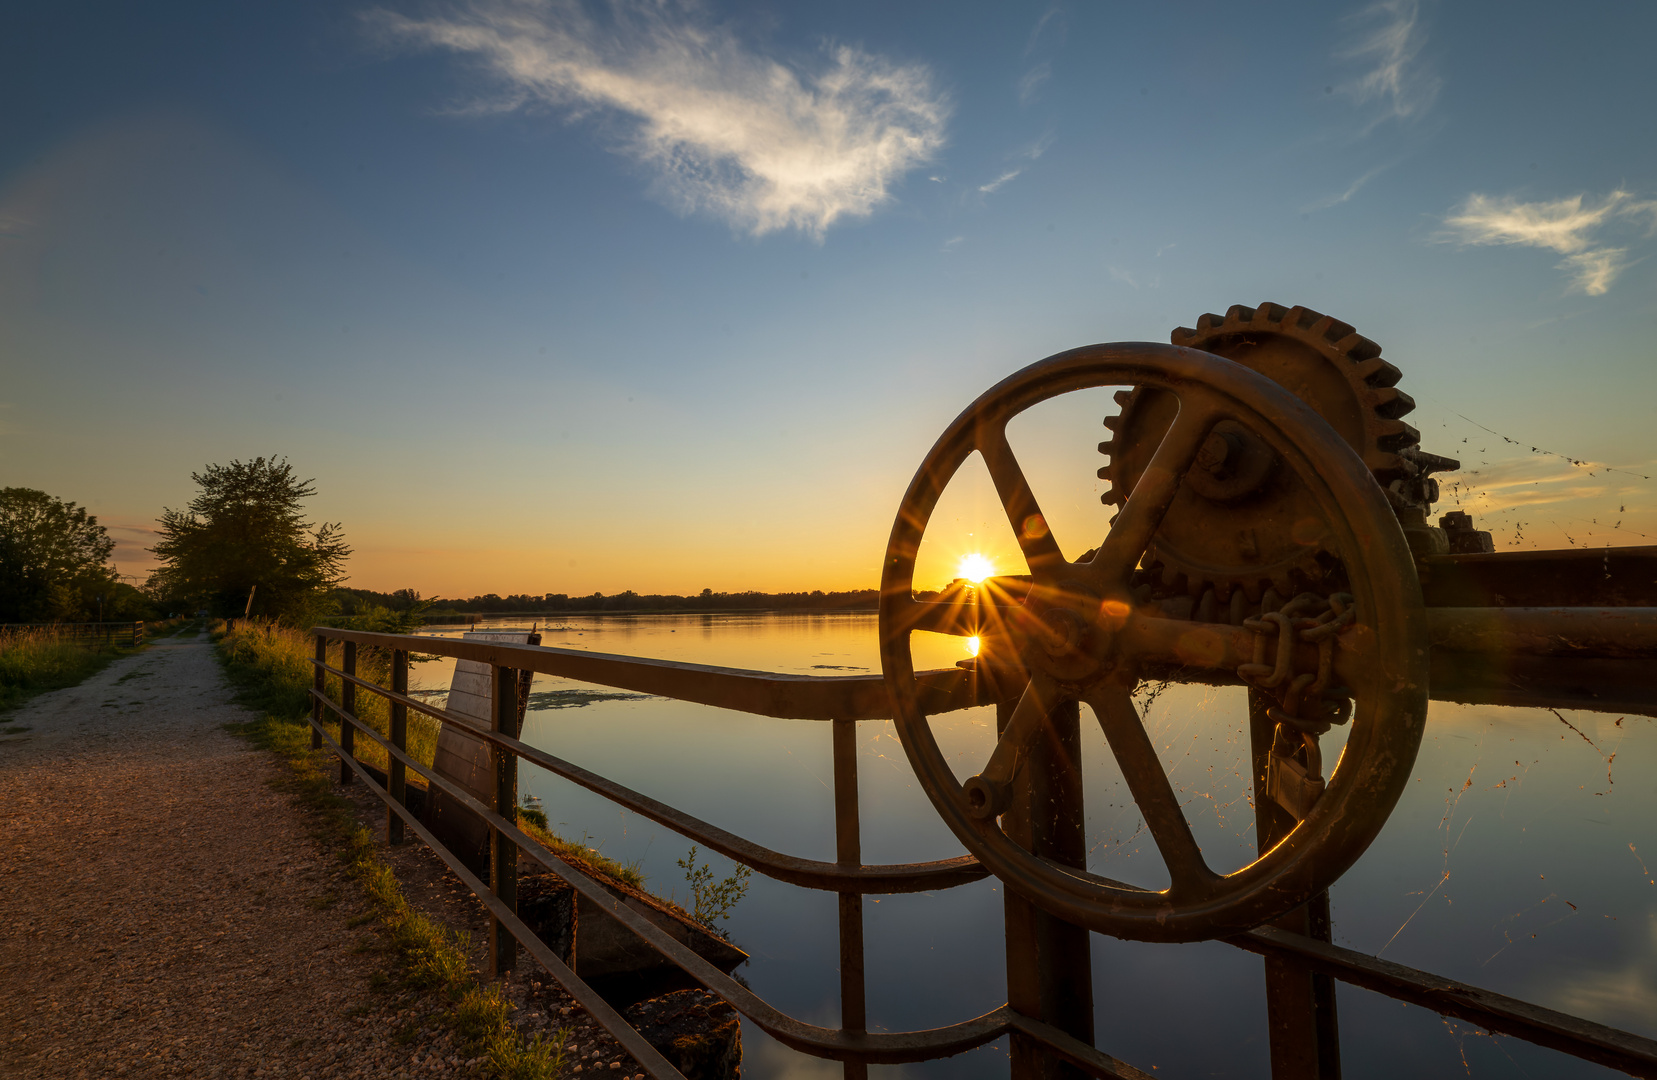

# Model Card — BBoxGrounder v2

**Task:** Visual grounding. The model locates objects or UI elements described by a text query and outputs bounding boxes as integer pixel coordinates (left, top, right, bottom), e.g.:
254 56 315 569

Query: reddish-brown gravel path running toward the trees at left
0 636 410 1077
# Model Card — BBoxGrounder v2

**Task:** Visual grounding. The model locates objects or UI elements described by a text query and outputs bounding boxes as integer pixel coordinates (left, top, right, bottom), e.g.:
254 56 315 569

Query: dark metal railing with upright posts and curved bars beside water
310 628 1657 1080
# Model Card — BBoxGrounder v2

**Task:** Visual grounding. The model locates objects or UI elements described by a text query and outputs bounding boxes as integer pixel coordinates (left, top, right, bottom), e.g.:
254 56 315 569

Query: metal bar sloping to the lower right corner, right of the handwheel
1246 926 1657 1078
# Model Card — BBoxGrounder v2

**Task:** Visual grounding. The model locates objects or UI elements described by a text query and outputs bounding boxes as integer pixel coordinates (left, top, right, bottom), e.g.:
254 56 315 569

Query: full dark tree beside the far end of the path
149 457 351 623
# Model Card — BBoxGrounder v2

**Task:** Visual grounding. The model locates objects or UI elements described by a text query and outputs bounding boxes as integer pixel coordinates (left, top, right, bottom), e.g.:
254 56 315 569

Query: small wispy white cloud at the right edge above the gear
1435 189 1657 297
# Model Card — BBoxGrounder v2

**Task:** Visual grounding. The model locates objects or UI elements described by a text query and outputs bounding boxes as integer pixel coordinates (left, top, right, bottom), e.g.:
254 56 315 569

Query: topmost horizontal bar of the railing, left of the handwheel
312 626 978 721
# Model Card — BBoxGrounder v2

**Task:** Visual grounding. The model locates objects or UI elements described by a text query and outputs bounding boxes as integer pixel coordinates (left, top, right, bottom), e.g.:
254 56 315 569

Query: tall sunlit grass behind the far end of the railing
219 620 441 771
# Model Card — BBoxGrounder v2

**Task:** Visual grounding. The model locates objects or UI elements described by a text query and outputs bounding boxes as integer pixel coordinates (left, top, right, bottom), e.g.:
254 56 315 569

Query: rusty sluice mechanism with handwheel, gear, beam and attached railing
312 305 1657 1080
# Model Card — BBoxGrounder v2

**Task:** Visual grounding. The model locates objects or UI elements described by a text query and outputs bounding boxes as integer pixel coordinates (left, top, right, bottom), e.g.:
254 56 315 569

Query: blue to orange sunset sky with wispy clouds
0 0 1657 596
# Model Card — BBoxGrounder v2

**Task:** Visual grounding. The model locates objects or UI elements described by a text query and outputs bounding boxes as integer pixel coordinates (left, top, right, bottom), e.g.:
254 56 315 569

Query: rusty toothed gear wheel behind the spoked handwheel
1099 303 1457 601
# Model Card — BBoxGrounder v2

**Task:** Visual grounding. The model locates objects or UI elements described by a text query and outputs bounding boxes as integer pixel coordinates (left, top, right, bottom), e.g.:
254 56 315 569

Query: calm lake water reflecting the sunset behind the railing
411 613 1657 1078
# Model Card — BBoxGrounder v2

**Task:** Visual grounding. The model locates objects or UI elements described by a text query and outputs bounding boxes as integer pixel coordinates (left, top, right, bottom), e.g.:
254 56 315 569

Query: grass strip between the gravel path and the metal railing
219 623 568 1080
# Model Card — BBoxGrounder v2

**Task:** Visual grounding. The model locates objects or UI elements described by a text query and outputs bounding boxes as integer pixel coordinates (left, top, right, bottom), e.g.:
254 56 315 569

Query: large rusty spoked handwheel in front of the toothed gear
880 343 1427 941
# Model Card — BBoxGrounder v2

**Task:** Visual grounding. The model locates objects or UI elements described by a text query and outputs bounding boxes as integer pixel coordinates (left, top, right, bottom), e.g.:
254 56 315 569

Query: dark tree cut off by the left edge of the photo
0 487 114 623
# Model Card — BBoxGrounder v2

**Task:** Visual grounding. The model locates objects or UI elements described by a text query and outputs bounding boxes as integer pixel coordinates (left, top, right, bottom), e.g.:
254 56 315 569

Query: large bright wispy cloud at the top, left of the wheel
368 0 949 237
